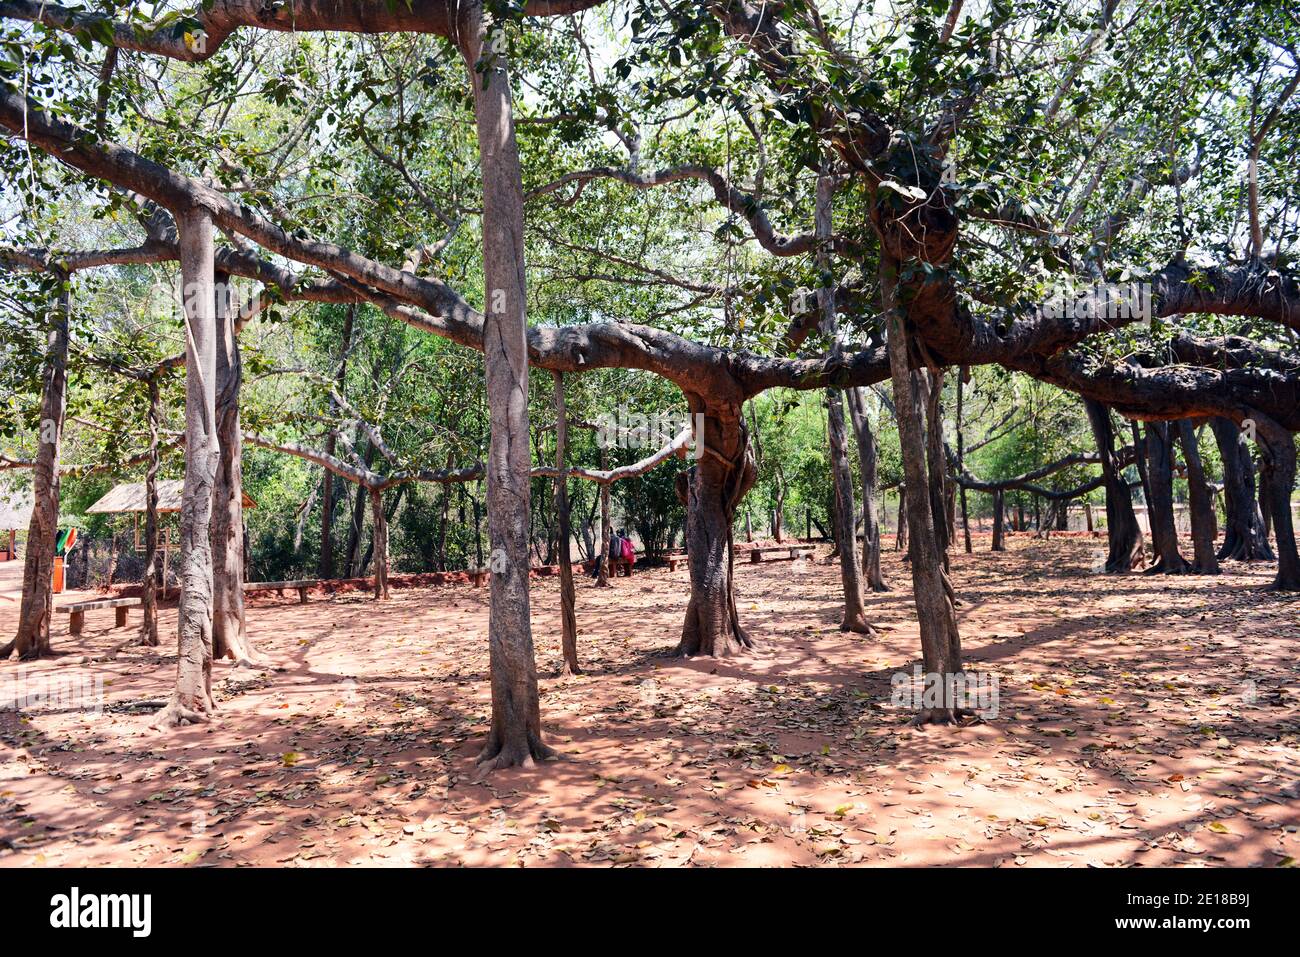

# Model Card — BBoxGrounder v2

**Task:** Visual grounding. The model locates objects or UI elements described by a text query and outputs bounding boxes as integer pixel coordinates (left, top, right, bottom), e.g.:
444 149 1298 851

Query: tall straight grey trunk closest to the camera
459 13 554 774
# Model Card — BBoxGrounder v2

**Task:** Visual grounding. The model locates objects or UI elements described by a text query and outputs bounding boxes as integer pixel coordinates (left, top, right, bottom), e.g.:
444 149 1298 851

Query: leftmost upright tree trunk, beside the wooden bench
0 276 72 661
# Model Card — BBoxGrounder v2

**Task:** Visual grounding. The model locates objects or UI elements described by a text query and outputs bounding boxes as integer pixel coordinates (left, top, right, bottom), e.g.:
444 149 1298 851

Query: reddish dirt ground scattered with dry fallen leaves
0 536 1300 867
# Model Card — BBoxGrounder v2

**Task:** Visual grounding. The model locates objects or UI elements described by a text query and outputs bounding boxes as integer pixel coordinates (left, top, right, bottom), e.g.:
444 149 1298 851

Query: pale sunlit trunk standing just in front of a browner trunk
157 207 221 727
